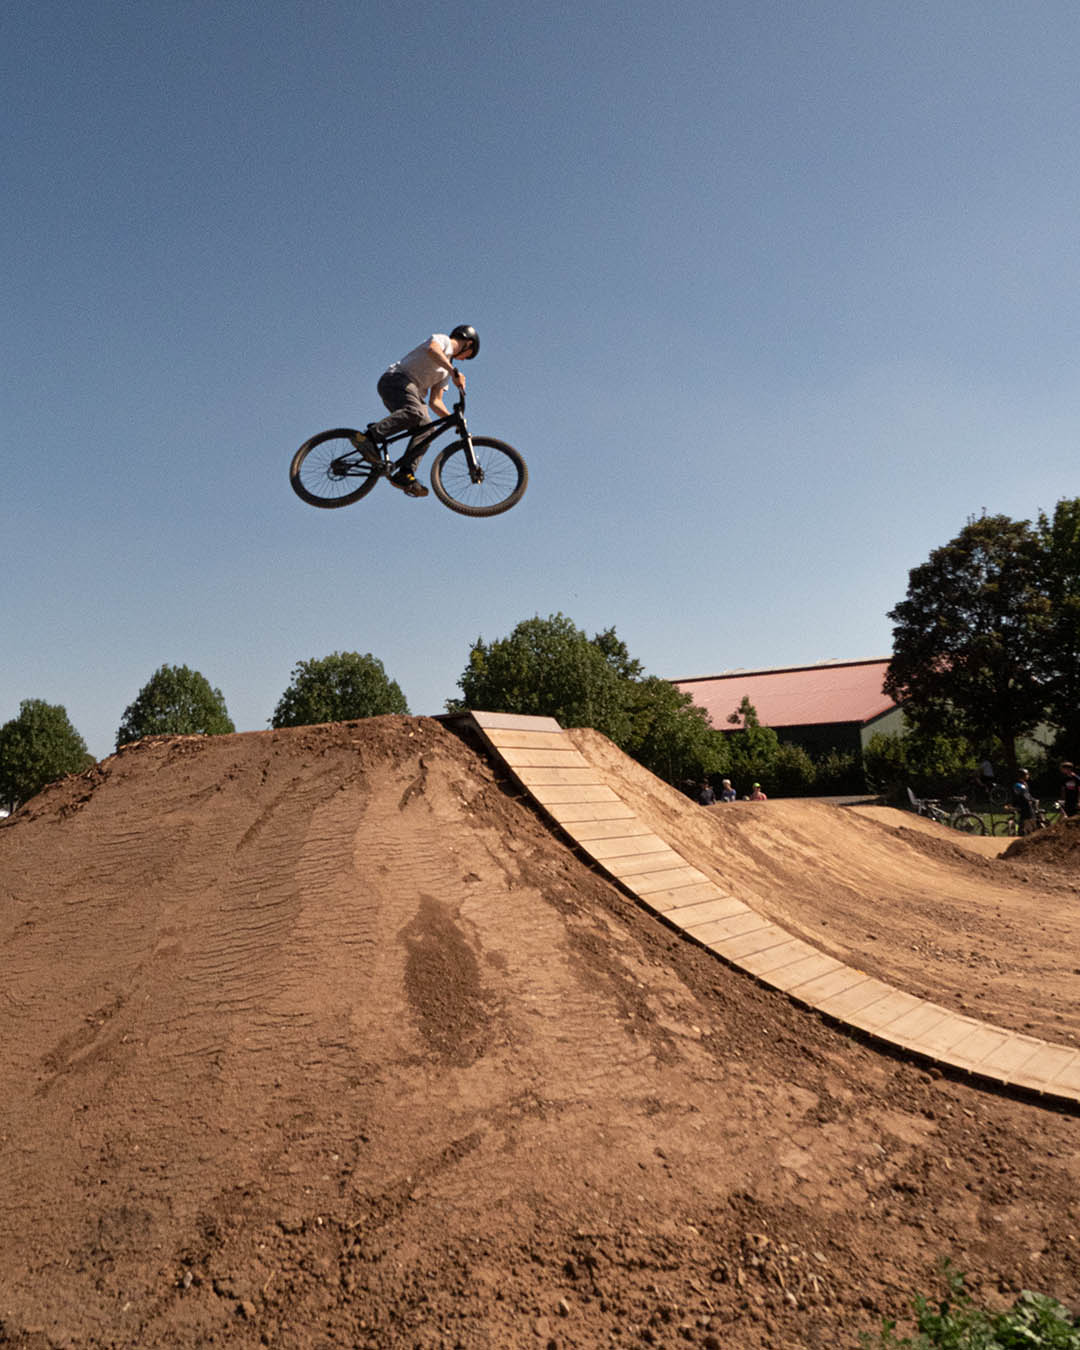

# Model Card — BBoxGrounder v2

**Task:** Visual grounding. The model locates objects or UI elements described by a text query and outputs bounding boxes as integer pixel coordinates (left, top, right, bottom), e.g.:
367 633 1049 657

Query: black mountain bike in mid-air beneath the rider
289 394 529 516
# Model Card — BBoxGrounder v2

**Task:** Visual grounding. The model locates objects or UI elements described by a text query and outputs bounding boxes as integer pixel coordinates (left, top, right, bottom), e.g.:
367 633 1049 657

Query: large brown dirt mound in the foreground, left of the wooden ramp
0 718 1080 1350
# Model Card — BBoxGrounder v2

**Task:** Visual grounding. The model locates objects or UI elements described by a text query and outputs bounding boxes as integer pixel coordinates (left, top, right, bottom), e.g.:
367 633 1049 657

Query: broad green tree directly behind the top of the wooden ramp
447 614 640 745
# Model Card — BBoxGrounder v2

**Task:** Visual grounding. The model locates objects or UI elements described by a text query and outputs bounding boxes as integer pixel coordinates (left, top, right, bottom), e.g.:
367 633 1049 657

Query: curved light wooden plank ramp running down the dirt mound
459 713 1080 1104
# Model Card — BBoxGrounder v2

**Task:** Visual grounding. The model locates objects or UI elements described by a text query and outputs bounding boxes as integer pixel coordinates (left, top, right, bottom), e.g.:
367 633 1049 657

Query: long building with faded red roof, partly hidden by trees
672 657 903 755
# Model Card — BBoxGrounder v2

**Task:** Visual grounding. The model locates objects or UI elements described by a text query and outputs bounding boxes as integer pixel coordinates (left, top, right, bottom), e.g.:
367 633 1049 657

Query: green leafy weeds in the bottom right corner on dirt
863 1264 1080 1350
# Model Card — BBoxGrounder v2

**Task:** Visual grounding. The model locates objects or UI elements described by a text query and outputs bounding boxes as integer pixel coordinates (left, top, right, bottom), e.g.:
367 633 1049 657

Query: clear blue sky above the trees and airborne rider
0 0 1080 756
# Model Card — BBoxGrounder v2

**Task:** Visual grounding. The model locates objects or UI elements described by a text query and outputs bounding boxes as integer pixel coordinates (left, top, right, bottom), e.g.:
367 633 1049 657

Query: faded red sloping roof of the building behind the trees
672 657 896 732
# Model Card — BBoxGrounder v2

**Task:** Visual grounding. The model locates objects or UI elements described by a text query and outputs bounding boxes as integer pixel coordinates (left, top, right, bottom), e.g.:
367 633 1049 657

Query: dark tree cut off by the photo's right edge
1037 497 1080 759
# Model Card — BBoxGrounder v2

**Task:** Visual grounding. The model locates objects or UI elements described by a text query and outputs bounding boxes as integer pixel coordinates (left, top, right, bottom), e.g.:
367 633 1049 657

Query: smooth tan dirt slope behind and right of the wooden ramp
571 730 1080 1045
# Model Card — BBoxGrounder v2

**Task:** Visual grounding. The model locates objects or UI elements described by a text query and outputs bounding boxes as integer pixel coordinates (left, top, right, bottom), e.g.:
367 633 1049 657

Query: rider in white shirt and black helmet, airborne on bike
365 324 481 497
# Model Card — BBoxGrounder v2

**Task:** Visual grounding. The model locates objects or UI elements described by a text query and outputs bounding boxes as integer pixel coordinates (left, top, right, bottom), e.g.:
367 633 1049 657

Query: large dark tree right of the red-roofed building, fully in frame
884 516 1049 771
